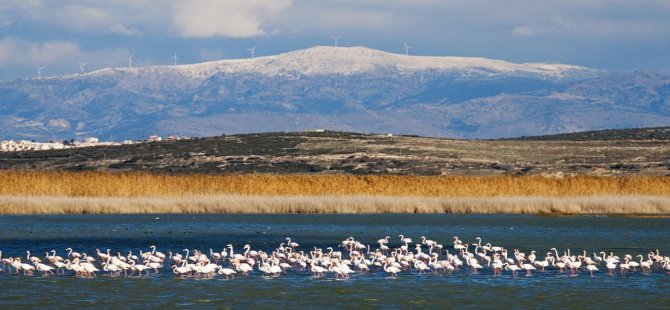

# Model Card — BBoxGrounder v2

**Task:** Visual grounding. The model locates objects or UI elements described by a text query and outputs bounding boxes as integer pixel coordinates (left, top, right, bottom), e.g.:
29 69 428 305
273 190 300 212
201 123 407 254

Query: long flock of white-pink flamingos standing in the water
0 235 670 279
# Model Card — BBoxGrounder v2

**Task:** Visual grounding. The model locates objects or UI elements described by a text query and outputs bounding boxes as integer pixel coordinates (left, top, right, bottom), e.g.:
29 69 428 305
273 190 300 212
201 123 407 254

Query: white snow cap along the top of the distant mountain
71 46 593 79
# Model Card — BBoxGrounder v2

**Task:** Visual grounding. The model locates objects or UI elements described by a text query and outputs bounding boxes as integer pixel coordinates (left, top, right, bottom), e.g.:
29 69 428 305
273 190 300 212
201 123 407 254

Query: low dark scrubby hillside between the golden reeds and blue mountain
0 127 670 176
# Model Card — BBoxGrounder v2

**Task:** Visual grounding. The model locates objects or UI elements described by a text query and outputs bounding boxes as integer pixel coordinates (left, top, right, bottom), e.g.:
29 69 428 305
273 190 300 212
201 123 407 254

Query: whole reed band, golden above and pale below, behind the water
0 172 670 215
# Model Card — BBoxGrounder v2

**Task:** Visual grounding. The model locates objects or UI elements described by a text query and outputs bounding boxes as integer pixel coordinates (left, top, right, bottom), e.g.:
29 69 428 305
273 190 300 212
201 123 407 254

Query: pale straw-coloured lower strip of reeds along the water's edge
0 195 670 215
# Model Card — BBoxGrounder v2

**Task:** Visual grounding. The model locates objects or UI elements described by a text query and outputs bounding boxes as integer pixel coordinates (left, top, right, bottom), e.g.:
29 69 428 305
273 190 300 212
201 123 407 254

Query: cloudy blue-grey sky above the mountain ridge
0 0 670 80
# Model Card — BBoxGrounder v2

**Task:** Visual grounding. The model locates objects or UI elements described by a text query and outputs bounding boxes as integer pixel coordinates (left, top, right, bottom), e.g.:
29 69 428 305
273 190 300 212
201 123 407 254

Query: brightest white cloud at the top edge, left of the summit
174 0 292 38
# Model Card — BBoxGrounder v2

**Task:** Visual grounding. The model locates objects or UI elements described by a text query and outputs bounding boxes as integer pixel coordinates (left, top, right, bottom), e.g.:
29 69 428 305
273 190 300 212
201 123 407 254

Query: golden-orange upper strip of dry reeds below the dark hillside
0 172 670 197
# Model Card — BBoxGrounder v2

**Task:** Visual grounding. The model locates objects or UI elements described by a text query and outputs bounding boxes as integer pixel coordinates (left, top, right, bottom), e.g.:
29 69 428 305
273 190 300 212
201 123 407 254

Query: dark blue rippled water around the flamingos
0 215 670 309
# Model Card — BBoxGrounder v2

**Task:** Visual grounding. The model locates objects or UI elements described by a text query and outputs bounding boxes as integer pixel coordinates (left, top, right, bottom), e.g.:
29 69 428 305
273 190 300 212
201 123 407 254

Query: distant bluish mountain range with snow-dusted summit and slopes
0 47 670 140
